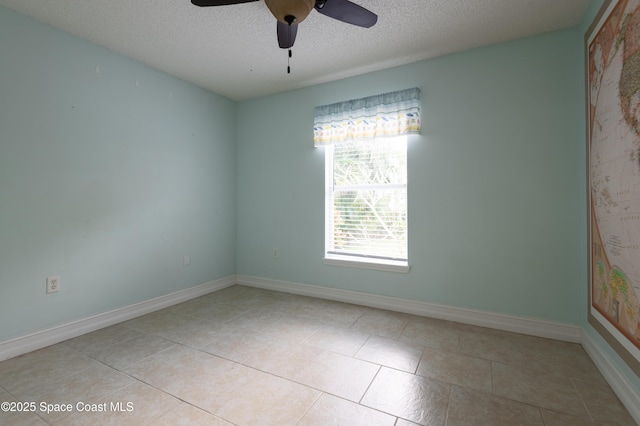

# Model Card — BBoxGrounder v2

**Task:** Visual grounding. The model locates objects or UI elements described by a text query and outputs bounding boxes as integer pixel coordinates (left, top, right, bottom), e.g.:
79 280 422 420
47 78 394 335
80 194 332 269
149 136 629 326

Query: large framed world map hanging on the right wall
586 0 640 370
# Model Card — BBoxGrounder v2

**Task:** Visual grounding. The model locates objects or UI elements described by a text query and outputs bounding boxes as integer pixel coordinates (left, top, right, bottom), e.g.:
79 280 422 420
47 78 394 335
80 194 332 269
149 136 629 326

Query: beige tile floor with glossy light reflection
0 286 635 426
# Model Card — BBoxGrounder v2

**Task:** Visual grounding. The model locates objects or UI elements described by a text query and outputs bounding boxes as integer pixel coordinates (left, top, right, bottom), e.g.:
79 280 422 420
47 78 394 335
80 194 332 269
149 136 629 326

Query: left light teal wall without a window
0 7 236 341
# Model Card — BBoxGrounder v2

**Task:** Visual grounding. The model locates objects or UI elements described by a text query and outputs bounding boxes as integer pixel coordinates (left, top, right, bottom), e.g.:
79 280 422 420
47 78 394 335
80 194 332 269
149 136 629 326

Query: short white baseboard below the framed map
582 331 640 424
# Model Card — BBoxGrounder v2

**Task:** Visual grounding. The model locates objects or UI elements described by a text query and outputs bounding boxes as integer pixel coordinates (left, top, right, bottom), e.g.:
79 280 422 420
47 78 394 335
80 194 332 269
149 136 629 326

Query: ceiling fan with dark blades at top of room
191 0 378 51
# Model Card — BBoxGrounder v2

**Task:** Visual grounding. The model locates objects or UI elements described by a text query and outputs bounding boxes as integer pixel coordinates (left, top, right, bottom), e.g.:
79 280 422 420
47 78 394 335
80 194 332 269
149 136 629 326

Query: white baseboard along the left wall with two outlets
0 275 236 361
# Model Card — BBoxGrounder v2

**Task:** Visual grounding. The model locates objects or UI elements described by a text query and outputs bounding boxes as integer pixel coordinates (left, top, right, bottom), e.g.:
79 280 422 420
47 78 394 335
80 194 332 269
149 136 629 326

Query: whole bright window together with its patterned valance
313 88 420 272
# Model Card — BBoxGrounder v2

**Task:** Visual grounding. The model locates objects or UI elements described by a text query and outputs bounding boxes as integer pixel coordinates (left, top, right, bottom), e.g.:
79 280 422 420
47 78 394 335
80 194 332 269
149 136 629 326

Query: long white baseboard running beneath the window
236 275 582 343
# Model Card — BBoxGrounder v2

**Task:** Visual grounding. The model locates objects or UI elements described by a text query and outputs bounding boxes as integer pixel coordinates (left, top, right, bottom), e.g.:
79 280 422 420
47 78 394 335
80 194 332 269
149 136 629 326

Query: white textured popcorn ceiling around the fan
0 0 589 100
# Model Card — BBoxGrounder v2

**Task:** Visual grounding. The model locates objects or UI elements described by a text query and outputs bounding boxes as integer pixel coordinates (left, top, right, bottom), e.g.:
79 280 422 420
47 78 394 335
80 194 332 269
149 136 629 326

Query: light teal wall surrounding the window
237 29 584 324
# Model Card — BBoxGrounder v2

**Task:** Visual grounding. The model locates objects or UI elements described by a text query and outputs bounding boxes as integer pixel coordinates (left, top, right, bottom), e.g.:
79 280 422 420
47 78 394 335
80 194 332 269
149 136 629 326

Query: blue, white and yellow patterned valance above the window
313 88 420 146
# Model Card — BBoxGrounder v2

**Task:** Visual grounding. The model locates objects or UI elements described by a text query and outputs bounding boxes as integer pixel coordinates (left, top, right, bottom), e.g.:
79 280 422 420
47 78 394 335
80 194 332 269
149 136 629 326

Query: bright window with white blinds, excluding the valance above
325 136 407 270
